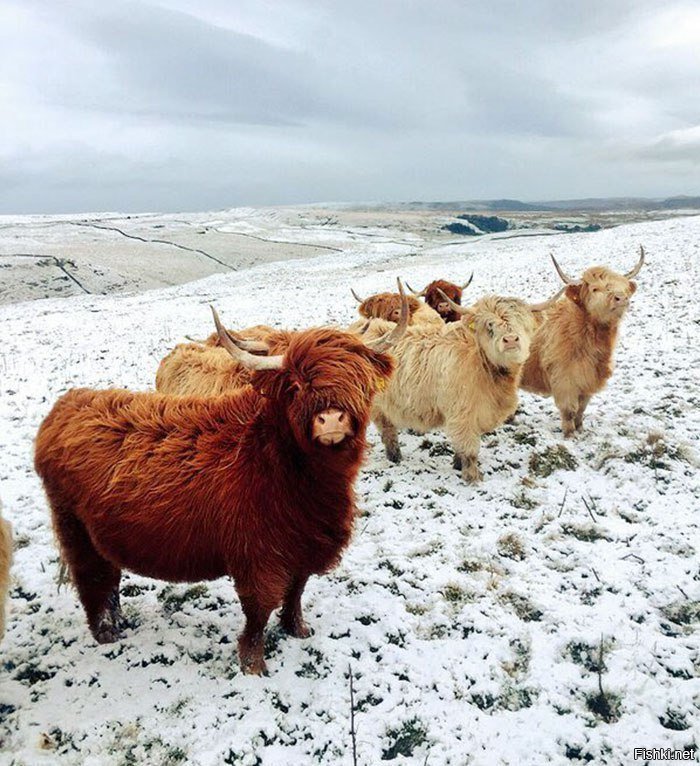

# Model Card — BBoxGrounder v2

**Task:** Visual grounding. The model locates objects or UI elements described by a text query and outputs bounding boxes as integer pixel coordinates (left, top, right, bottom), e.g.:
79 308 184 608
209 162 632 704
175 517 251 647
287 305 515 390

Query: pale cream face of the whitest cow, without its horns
462 295 536 367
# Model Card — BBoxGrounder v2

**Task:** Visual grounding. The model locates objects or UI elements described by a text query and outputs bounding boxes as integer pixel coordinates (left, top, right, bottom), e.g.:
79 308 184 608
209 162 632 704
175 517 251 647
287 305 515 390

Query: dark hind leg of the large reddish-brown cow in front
53 508 123 644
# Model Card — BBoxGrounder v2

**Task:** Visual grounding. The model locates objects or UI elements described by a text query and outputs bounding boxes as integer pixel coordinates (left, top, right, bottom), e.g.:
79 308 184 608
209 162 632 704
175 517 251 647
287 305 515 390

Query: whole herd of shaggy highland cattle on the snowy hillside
0 248 644 674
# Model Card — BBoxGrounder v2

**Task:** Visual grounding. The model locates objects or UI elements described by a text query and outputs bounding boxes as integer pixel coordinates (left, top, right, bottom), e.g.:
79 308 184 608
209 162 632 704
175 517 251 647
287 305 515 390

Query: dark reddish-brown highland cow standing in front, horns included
35 308 408 673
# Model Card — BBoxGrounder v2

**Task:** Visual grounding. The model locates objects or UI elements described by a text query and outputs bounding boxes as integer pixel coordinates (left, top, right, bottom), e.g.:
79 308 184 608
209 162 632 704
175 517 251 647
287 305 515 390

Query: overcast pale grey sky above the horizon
0 0 700 213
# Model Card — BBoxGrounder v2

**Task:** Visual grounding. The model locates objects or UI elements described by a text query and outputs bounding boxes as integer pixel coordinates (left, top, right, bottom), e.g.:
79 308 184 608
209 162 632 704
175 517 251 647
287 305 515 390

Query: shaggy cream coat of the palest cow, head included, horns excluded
367 296 535 481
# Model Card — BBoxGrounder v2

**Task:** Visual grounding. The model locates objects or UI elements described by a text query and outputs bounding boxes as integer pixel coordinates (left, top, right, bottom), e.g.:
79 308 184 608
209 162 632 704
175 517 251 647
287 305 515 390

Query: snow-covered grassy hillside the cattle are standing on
0 217 700 766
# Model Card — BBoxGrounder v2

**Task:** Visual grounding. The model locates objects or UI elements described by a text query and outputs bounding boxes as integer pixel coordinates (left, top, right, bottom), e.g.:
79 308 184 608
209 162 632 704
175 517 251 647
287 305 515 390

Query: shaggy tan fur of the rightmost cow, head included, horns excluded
520 266 637 436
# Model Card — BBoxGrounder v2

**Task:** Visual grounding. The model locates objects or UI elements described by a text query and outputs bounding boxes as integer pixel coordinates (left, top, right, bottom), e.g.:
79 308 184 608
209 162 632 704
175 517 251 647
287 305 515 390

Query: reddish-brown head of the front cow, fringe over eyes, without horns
253 329 393 452
